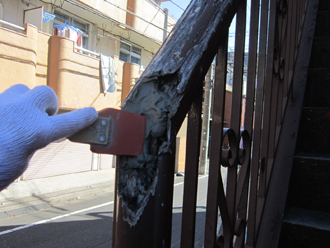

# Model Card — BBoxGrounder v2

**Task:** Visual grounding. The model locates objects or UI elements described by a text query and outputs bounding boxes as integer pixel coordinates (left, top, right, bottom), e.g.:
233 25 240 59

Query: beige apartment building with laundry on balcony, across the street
0 0 175 180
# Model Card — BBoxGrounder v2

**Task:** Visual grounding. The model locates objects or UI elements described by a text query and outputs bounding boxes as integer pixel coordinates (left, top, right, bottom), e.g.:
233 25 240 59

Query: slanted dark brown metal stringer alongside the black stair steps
256 0 318 248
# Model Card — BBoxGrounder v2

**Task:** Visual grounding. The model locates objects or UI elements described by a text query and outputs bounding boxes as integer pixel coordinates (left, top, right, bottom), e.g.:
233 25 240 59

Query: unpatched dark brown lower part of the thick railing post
112 149 175 248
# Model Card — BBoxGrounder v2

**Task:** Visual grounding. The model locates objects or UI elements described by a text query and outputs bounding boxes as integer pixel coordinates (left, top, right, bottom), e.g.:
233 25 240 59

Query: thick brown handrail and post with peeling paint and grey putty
113 0 240 247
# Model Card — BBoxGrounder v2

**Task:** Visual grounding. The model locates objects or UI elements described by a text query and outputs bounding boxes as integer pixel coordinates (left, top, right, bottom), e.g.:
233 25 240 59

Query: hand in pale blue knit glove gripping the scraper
0 85 98 190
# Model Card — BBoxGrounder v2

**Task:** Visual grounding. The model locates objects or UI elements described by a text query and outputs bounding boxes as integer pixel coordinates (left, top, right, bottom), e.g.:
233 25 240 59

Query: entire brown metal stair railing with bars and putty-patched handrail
113 0 316 248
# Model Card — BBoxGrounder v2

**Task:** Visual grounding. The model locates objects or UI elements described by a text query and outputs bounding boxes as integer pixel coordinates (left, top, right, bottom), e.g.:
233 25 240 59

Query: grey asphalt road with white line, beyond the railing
0 177 207 248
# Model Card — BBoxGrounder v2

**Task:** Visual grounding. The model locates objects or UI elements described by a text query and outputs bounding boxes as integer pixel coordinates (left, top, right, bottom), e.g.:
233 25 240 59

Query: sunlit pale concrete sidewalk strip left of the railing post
0 168 115 219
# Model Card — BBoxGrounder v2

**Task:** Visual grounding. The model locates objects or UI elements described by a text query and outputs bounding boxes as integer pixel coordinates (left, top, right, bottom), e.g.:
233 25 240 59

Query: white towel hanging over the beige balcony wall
100 54 116 93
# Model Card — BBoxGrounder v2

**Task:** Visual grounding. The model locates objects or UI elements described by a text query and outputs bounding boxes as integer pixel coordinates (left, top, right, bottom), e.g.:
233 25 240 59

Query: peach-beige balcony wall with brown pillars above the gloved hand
0 20 144 110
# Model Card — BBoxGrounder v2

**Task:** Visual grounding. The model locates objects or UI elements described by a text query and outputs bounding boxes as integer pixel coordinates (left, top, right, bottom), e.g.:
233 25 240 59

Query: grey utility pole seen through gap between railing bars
199 63 214 175
